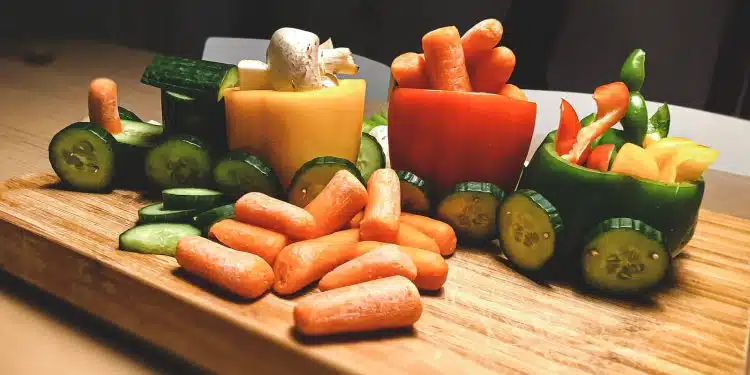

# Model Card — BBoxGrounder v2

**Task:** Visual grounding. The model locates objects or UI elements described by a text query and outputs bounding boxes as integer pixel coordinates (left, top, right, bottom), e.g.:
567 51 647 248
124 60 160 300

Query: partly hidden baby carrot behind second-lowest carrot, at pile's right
357 241 448 290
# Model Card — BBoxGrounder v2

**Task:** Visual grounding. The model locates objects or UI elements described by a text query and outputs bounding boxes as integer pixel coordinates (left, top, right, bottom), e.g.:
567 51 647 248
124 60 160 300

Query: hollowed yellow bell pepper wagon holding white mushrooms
224 79 366 188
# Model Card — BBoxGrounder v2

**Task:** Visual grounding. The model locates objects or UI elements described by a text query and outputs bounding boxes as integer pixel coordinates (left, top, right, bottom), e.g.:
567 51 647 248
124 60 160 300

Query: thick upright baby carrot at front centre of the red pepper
422 26 471 91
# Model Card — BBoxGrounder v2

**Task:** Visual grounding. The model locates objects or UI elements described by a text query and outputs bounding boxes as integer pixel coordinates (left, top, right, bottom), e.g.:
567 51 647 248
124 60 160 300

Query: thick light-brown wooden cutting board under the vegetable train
0 174 750 374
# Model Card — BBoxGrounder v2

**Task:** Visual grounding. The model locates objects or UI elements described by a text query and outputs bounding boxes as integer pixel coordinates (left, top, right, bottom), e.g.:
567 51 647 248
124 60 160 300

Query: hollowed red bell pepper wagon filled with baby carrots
388 88 536 194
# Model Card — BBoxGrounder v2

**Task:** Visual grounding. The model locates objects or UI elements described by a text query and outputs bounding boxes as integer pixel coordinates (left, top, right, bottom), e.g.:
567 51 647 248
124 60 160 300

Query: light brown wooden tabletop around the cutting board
0 42 750 374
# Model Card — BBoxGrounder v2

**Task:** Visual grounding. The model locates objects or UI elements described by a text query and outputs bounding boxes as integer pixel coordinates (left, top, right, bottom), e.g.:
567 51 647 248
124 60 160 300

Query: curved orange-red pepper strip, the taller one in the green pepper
563 82 630 165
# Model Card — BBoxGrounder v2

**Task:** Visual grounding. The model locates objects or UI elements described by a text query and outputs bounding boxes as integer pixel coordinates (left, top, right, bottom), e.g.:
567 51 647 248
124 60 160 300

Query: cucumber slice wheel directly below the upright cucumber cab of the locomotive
146 135 212 189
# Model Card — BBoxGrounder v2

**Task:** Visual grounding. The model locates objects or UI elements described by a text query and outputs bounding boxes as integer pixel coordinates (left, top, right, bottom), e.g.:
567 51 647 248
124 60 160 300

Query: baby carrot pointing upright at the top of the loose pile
359 168 401 242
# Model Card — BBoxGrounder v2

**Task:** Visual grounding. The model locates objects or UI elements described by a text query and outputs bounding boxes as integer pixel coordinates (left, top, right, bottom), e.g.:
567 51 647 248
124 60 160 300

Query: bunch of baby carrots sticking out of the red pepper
391 18 528 100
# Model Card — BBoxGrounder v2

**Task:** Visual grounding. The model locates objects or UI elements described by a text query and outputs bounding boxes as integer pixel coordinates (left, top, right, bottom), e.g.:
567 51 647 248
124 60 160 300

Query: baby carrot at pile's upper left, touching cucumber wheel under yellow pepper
234 192 317 240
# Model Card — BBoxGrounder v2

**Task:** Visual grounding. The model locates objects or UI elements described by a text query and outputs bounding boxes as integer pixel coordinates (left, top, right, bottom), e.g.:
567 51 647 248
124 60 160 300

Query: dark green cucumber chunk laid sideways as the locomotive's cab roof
141 56 239 102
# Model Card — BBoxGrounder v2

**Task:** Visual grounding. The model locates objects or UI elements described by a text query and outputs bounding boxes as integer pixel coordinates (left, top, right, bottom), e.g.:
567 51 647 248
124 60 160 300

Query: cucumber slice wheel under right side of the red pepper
437 182 505 242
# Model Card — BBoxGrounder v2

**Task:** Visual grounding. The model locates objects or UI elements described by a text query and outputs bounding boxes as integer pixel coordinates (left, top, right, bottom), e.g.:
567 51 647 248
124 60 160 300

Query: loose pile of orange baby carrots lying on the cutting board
175 168 456 335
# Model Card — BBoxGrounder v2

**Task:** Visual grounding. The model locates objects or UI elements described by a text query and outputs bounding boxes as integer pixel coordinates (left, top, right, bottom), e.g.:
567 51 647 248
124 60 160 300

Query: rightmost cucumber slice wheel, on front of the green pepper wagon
583 218 670 293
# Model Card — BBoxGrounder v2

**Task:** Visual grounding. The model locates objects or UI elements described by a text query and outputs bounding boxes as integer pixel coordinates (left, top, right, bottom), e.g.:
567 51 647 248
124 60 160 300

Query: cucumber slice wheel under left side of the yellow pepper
213 150 283 198
